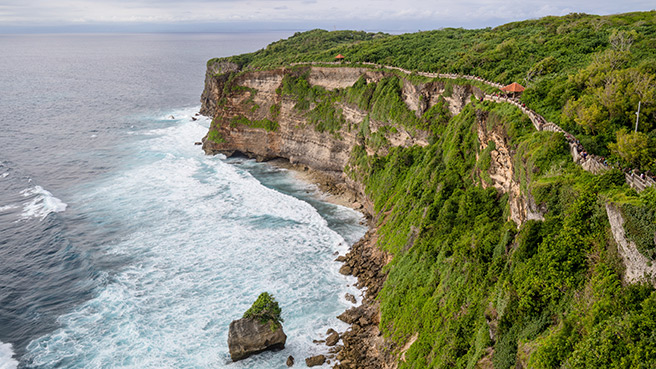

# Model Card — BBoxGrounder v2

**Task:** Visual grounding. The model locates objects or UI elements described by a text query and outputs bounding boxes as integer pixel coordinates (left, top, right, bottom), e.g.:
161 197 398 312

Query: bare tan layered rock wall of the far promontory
201 65 440 186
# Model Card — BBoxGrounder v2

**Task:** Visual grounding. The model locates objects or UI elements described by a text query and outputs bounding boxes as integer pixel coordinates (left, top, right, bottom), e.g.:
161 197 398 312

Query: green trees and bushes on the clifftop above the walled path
211 11 656 172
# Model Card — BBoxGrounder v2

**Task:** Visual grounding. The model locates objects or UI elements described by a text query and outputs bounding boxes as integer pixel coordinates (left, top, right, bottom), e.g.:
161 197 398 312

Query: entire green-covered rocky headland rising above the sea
202 12 656 368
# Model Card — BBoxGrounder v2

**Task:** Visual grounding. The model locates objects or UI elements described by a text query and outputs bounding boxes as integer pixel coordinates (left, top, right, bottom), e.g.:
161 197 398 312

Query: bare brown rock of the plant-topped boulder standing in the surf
228 318 287 361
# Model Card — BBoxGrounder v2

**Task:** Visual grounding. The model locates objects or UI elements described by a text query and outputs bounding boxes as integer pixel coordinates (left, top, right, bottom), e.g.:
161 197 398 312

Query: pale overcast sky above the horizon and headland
0 0 656 33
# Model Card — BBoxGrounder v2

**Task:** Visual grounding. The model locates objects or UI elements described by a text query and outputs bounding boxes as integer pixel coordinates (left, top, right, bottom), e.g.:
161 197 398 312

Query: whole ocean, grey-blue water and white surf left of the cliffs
0 33 366 369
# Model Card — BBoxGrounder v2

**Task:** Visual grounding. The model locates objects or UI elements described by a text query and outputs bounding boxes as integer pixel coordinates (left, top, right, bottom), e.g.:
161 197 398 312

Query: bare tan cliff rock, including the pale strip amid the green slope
201 62 545 225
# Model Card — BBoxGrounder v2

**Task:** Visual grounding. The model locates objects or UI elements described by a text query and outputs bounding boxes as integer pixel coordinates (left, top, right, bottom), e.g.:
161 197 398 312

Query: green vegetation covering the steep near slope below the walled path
349 104 656 368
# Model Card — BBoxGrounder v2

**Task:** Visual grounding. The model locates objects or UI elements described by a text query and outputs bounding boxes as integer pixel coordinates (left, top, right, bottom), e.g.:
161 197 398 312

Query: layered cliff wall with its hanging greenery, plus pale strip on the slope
201 62 541 224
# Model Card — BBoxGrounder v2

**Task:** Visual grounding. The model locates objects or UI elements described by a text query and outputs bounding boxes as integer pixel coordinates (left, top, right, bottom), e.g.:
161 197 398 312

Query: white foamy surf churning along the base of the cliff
24 108 364 368
